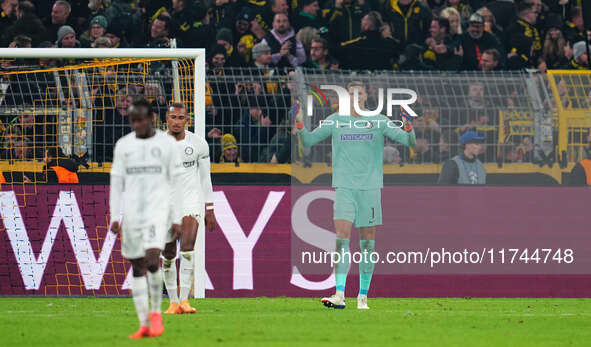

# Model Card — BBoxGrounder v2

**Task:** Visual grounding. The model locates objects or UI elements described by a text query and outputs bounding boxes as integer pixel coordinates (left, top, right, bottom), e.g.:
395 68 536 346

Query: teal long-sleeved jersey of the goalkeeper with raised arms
301 113 416 190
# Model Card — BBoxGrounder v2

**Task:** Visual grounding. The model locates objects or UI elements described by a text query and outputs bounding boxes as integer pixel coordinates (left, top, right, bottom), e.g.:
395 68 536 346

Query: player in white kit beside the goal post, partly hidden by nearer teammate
162 103 215 314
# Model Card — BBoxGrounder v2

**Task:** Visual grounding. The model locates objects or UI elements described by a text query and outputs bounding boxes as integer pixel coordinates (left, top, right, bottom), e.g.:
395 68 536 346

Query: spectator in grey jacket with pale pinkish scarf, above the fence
262 12 306 67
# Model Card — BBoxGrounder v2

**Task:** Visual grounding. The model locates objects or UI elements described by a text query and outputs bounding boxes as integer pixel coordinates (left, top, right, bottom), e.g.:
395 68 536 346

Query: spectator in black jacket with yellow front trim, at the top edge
382 0 432 47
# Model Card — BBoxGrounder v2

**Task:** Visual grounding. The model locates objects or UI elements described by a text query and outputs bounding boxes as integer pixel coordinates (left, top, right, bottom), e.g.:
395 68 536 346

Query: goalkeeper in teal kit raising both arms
296 81 416 309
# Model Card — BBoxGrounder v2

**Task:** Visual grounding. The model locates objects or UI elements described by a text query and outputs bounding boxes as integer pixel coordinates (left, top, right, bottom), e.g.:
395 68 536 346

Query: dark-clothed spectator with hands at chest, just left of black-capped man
423 18 461 71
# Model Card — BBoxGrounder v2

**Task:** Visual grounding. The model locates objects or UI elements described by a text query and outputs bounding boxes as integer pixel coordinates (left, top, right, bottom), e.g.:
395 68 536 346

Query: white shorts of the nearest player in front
121 223 167 259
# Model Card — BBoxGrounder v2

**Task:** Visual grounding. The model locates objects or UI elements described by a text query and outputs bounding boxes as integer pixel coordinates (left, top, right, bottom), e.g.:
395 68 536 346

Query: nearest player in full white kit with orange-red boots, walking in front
109 99 182 339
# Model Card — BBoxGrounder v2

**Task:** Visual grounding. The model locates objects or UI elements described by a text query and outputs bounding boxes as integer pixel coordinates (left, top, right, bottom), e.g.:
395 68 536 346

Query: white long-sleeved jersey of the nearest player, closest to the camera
110 130 182 228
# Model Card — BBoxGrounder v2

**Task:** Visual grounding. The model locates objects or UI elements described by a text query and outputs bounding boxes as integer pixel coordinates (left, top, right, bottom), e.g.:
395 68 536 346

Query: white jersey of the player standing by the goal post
176 130 212 216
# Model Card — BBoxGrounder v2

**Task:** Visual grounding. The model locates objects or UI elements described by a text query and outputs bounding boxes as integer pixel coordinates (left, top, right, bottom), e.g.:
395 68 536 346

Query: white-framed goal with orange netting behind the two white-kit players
0 48 205 297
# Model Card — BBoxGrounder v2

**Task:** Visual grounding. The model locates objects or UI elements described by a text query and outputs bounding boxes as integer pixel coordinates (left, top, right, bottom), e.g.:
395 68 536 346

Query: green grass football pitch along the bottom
0 297 591 347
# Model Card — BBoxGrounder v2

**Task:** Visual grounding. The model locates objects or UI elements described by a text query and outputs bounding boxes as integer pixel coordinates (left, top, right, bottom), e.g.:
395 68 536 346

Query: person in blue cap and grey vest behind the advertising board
437 131 486 185
